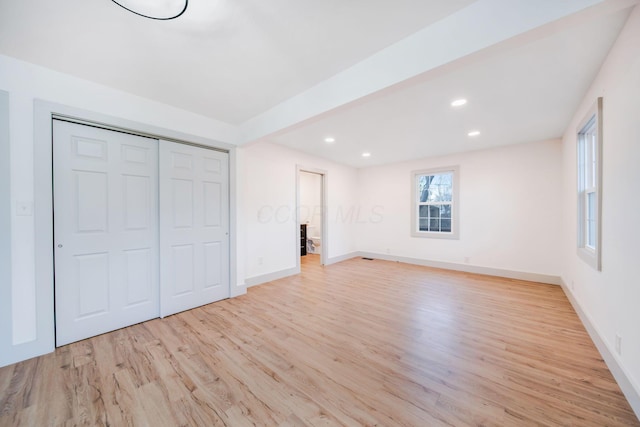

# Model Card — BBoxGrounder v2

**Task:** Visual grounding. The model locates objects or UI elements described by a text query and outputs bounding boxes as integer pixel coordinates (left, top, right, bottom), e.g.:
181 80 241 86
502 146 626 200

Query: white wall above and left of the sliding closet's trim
0 55 238 365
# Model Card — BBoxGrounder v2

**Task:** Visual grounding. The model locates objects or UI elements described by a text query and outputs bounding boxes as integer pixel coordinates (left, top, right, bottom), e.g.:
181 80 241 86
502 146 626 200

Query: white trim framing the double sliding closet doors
26 99 241 361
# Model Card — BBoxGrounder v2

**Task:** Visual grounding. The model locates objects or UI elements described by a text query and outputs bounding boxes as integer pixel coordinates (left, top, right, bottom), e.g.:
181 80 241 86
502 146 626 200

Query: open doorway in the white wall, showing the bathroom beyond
296 167 328 265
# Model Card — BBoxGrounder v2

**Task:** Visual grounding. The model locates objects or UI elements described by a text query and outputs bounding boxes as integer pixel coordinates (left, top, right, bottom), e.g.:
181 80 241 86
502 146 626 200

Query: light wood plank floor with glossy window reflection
0 256 640 427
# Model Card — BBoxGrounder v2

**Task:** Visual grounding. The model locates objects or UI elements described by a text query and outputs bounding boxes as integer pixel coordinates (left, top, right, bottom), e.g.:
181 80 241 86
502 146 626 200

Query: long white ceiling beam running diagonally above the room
240 0 624 144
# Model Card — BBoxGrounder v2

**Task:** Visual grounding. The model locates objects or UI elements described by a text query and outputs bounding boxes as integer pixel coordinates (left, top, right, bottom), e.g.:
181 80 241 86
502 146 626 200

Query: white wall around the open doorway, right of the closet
238 142 358 282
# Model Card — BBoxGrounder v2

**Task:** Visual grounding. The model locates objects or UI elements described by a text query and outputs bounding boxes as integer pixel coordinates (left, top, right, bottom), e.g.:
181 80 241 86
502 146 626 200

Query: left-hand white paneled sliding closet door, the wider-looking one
53 120 159 346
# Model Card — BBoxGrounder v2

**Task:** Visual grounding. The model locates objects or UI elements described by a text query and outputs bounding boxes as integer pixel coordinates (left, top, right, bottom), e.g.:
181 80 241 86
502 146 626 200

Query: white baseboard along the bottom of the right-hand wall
560 279 640 419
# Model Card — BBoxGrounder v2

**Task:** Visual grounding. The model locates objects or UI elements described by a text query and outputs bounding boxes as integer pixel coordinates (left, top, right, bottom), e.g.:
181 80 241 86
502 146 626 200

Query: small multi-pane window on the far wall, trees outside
411 166 458 239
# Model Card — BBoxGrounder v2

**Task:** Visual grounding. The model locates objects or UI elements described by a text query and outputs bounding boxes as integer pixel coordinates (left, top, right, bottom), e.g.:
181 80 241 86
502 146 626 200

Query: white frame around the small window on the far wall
411 166 460 239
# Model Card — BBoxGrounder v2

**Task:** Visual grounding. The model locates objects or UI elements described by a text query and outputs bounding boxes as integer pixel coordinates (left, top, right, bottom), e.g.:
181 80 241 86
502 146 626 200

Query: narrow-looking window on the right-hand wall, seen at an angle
577 98 602 270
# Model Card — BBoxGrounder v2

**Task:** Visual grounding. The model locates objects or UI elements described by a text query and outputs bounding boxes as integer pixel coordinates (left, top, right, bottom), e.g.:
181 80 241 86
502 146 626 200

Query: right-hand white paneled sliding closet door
160 140 229 317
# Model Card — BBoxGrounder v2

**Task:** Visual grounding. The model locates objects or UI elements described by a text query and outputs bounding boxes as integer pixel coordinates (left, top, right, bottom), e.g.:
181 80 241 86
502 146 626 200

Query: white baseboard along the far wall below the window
358 252 561 285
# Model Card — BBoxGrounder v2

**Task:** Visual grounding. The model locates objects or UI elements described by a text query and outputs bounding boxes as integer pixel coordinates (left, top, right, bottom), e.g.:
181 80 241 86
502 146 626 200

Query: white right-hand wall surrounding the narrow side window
561 7 640 414
